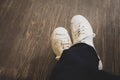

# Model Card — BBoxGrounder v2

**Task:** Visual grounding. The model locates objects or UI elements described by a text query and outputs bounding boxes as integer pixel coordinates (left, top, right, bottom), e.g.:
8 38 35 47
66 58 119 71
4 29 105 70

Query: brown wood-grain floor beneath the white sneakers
0 0 120 80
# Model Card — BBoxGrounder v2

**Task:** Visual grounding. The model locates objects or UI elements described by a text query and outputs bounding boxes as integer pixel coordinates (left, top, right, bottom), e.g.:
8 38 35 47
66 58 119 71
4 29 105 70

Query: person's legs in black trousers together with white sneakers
50 15 120 80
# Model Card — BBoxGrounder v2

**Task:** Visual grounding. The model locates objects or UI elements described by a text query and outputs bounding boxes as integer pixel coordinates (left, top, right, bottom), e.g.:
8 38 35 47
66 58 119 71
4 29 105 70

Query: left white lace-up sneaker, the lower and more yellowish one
51 27 72 60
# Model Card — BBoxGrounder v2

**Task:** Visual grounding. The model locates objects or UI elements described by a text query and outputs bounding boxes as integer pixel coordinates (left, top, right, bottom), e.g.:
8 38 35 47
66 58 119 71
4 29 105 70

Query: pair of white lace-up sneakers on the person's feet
51 15 103 70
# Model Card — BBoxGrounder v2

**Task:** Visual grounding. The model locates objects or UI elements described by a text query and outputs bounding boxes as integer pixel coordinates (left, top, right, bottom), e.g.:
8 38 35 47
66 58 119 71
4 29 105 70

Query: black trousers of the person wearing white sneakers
50 43 120 80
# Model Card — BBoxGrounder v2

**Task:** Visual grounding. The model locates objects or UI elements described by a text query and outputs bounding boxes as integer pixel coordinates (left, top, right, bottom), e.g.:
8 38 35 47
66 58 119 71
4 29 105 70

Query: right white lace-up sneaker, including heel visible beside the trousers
71 15 103 70
